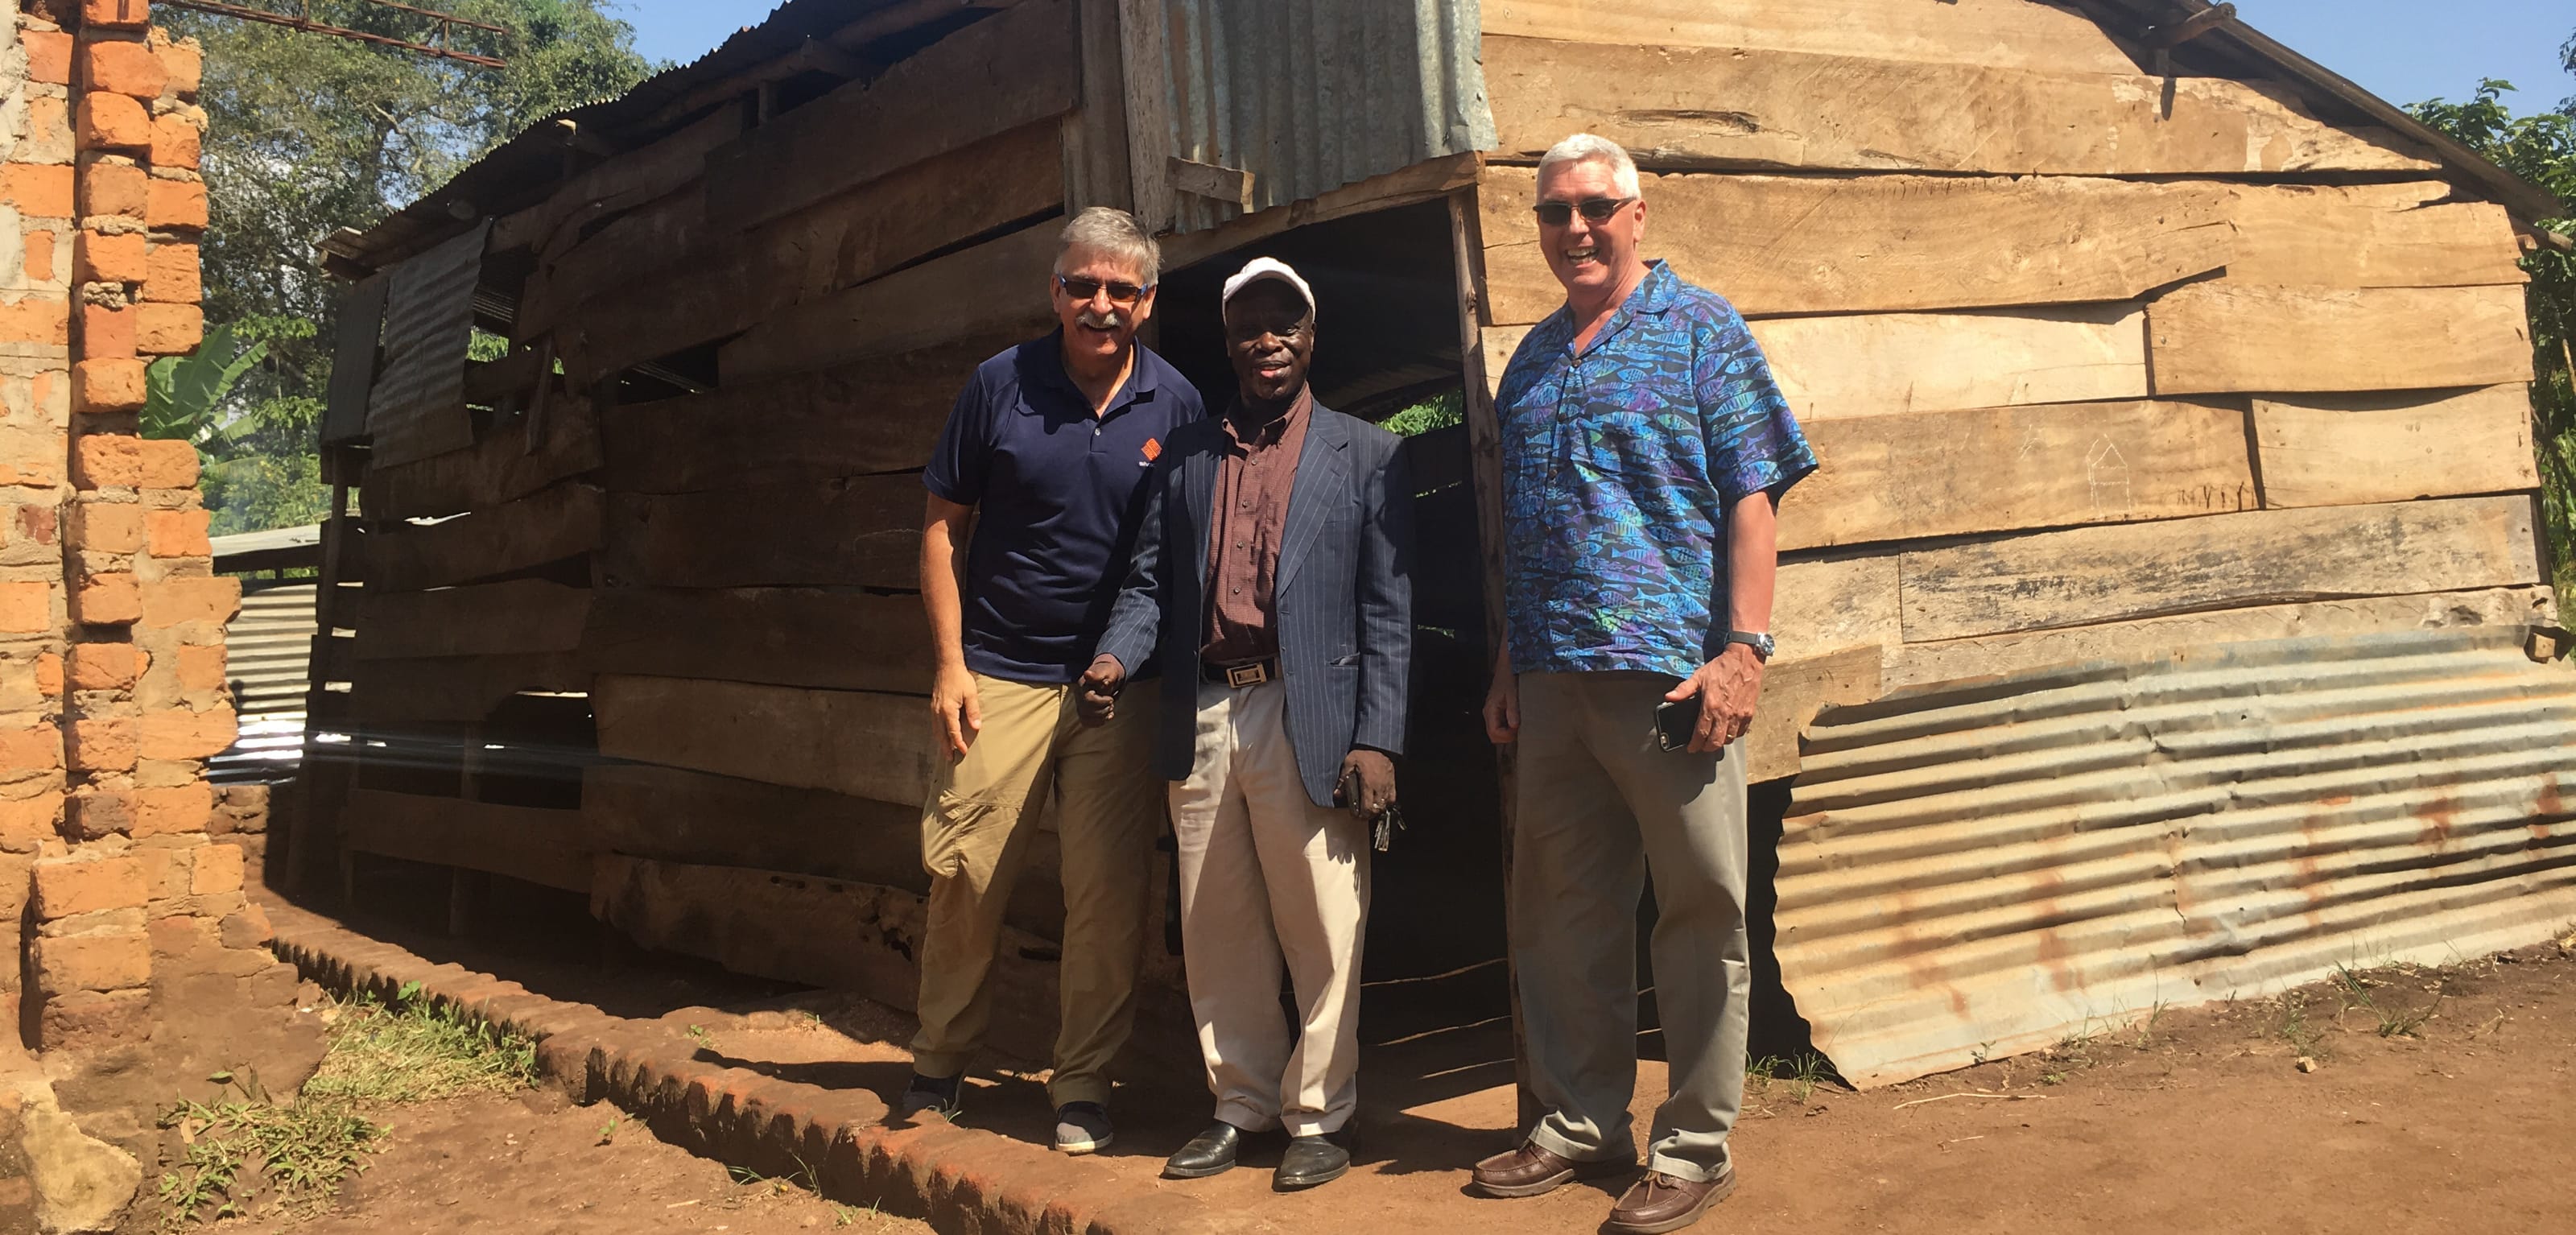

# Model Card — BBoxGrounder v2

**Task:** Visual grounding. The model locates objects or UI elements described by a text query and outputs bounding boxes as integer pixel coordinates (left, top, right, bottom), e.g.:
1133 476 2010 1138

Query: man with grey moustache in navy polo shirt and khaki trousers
902 206 1206 1153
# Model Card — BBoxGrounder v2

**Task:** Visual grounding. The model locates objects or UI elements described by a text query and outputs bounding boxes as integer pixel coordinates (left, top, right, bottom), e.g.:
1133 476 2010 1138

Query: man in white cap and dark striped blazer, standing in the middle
1082 258 1412 1192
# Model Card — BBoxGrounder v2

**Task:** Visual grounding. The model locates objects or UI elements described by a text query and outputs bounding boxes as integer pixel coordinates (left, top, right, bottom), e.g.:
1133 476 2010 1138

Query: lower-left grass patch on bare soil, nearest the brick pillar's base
159 1072 386 1230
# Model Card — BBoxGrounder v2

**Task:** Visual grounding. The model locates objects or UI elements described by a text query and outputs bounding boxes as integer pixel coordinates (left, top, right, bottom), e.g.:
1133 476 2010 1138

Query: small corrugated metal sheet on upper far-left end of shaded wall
365 219 492 467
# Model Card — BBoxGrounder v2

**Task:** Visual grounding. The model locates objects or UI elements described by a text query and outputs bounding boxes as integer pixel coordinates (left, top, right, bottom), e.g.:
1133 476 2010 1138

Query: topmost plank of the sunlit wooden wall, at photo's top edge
1481 0 2138 75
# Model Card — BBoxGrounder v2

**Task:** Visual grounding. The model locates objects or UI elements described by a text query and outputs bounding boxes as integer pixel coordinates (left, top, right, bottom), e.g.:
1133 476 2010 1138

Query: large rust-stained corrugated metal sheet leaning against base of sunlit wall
1777 629 2576 1085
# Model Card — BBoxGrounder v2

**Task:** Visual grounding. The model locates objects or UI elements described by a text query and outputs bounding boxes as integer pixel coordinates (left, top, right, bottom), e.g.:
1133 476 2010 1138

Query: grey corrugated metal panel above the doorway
1149 0 1494 232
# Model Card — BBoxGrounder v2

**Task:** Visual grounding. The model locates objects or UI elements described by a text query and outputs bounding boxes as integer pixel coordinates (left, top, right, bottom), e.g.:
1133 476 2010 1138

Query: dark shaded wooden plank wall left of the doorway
332 0 1125 948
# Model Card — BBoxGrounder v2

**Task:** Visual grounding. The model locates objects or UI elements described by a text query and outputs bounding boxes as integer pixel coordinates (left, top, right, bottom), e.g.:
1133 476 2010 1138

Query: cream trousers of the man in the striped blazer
1169 680 1368 1137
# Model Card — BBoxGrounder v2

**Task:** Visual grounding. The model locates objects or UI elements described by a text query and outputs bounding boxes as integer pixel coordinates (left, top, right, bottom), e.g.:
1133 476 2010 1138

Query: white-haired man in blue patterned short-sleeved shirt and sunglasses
1476 134 1816 1235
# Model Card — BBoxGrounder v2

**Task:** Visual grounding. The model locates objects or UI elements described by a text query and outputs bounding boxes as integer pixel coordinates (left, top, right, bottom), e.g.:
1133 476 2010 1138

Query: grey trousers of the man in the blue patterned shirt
1512 673 1752 1181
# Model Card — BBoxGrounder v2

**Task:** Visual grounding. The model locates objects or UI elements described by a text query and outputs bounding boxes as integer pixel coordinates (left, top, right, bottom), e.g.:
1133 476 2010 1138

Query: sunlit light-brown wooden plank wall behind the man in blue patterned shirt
1479 0 2545 779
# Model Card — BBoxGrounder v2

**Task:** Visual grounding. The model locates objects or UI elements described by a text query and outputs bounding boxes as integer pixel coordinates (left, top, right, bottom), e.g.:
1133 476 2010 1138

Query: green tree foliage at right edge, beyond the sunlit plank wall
2409 34 2576 624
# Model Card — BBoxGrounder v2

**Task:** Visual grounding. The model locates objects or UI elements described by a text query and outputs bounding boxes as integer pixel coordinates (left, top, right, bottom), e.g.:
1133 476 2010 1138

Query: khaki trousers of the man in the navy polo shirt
912 673 1162 1106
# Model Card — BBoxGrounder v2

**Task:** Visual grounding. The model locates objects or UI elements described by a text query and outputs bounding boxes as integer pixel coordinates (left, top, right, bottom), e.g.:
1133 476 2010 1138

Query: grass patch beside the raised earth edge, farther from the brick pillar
304 995 536 1104
